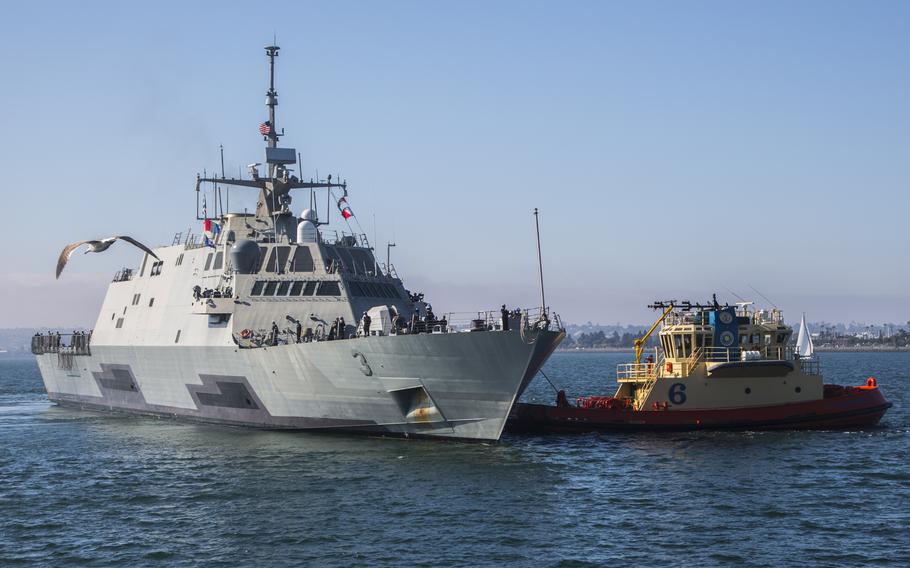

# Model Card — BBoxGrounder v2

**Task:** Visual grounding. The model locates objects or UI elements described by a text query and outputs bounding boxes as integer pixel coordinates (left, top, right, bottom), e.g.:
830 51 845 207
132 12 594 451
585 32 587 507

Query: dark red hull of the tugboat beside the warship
506 385 891 433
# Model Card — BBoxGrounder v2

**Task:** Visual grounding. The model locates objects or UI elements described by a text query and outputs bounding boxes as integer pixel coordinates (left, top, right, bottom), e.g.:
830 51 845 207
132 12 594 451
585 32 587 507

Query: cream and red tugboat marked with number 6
507 297 891 433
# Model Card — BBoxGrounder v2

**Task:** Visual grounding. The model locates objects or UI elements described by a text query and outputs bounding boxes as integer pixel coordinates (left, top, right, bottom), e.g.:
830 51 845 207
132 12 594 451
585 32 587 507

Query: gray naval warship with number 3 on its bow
32 46 565 440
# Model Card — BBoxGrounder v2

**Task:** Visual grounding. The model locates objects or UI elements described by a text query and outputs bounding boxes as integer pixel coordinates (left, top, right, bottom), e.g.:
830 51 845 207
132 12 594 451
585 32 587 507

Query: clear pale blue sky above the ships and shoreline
0 1 910 327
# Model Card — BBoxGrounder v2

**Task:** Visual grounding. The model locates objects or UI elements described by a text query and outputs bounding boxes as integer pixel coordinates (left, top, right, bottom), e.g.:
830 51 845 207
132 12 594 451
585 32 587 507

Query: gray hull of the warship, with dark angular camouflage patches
38 331 564 440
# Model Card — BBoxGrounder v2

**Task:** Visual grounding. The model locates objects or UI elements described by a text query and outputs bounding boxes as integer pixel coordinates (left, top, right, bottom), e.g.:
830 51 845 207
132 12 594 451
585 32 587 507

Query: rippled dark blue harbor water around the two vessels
0 353 910 566
